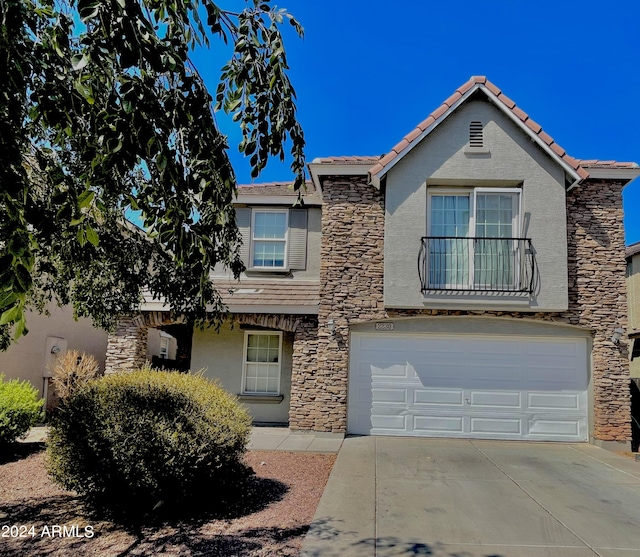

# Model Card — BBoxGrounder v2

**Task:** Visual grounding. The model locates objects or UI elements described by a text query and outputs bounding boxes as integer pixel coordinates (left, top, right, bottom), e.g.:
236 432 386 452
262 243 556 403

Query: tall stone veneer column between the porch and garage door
290 176 385 433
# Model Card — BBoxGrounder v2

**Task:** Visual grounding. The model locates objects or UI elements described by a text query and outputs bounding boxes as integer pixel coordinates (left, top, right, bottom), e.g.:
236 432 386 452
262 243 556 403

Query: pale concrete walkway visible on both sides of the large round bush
22 426 344 453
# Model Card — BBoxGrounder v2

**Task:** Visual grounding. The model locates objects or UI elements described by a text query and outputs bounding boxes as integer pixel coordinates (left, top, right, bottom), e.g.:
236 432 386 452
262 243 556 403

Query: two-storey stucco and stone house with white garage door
107 77 640 448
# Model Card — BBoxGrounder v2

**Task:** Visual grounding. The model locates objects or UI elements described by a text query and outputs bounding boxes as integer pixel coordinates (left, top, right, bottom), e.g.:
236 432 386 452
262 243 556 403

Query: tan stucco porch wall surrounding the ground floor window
191 323 292 423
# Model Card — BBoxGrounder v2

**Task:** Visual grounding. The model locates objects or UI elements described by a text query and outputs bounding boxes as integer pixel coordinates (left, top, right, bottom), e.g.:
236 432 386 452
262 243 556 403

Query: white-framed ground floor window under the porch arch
242 331 282 395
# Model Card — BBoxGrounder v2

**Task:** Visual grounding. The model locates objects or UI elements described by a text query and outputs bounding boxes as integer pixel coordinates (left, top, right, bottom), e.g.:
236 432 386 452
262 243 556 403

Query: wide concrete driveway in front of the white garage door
302 437 640 557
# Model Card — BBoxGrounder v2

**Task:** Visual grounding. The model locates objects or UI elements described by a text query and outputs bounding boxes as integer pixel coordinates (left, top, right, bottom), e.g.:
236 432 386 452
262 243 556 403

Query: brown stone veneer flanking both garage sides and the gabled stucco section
290 177 631 442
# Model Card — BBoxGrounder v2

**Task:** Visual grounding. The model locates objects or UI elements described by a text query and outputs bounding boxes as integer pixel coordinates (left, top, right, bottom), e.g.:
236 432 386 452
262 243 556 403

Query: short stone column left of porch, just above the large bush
105 317 147 373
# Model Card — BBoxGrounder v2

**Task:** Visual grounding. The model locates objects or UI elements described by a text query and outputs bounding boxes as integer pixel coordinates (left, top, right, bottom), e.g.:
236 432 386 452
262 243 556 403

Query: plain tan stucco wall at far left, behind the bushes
0 305 107 396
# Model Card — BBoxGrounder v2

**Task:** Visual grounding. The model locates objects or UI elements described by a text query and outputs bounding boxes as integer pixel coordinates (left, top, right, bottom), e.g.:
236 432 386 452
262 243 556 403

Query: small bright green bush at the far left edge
0 374 43 445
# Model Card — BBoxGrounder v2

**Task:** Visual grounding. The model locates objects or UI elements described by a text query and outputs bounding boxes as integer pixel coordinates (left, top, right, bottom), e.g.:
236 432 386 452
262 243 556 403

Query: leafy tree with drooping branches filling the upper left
0 0 304 347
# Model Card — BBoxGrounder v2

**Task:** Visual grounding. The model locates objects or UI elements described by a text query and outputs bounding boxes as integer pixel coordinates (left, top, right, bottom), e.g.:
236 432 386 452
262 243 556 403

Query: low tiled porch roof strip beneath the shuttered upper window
214 279 320 313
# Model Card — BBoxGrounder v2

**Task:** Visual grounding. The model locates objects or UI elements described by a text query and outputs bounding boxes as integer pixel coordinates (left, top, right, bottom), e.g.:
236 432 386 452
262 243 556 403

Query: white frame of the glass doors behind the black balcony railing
425 186 522 290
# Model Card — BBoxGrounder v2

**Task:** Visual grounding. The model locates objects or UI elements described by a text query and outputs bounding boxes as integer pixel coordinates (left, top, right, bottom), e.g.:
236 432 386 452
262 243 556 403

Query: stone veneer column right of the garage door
567 180 631 449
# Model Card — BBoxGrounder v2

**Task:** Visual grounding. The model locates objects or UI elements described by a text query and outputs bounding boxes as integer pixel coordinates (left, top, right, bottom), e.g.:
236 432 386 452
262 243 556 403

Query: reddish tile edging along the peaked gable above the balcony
369 76 589 179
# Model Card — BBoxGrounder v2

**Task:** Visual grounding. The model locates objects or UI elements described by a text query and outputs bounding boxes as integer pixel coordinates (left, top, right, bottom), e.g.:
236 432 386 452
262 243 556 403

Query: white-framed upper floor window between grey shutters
251 210 289 269
